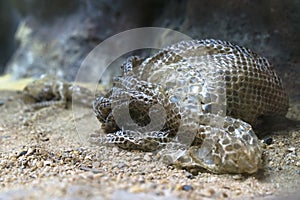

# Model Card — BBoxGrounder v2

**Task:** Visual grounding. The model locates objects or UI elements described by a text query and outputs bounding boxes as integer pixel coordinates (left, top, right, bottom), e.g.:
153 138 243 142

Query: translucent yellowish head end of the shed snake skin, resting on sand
159 114 262 174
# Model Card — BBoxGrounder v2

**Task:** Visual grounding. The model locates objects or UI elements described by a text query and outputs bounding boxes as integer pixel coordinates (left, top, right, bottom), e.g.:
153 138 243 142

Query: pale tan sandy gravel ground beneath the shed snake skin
0 77 300 200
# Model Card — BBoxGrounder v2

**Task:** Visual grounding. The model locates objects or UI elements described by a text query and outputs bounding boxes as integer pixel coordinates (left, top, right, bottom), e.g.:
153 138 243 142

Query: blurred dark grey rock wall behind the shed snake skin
0 0 300 99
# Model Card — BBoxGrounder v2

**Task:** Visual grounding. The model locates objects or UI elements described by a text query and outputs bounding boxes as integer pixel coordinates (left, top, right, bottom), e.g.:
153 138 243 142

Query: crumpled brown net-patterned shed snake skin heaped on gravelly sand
94 39 288 174
